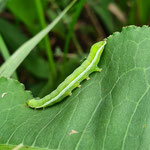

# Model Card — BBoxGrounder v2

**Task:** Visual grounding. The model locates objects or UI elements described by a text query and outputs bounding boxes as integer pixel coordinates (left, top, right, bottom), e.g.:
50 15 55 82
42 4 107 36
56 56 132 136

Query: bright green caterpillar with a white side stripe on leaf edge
27 40 106 108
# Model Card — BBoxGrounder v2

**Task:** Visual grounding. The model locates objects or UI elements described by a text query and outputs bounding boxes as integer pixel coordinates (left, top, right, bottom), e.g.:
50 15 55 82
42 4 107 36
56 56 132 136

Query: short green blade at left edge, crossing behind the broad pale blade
0 34 18 79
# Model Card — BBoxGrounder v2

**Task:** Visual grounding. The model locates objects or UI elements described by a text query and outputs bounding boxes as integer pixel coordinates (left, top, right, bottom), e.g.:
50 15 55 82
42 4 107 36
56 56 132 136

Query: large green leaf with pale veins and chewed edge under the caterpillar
0 26 150 150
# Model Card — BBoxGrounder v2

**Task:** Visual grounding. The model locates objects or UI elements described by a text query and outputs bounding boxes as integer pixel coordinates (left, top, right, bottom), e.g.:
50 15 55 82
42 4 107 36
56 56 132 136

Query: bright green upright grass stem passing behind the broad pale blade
35 0 57 78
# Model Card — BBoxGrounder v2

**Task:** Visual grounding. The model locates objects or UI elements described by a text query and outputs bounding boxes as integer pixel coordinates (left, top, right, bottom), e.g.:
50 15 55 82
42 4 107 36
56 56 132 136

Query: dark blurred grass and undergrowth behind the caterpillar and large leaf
0 0 150 97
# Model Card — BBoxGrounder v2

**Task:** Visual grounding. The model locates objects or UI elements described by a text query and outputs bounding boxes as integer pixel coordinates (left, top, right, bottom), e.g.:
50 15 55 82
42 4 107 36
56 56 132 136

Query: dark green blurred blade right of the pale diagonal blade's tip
63 0 86 62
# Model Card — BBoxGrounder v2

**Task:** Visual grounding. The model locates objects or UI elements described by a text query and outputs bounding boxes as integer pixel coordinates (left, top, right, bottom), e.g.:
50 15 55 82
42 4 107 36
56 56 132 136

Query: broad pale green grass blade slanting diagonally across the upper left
0 0 77 77
